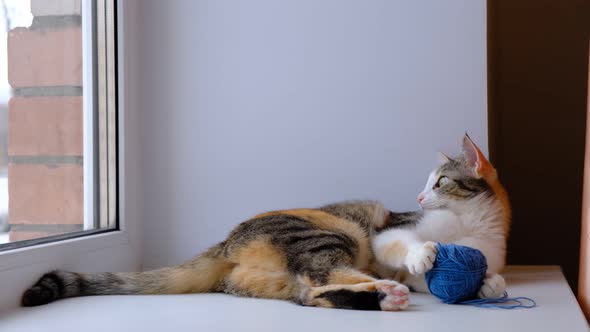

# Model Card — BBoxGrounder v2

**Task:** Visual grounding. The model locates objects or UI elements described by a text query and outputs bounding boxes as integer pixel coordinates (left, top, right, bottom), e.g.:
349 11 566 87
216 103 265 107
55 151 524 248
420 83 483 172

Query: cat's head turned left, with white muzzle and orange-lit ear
418 134 510 214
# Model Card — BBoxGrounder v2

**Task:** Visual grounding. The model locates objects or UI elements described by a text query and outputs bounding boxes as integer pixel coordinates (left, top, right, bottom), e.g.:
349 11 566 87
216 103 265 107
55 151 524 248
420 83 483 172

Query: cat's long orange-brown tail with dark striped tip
22 244 233 307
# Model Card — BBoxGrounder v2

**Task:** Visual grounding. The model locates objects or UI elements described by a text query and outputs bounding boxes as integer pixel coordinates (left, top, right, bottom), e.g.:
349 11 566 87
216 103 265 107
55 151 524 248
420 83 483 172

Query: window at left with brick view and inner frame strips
0 0 117 250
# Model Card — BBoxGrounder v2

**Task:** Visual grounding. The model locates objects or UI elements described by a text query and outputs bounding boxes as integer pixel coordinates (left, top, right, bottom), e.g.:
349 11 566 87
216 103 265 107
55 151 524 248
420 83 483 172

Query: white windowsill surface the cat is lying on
0 266 588 332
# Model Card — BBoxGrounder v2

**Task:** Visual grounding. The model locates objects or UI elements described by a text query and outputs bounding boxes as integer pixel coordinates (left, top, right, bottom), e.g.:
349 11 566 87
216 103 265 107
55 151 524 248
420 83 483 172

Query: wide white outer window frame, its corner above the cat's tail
0 0 142 311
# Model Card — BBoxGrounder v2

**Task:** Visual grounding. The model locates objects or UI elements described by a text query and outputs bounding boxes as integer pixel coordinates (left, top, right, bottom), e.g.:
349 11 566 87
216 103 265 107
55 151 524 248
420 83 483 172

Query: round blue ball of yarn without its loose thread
426 243 488 304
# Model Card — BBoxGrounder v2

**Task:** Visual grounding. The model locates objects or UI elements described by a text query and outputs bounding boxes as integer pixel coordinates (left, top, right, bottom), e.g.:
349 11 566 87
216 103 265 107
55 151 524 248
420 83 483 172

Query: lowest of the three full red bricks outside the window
8 164 84 224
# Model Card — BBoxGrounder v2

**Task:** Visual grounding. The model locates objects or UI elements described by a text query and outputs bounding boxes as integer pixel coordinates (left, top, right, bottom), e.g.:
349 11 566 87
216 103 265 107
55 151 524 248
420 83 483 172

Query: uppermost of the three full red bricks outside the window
8 27 82 88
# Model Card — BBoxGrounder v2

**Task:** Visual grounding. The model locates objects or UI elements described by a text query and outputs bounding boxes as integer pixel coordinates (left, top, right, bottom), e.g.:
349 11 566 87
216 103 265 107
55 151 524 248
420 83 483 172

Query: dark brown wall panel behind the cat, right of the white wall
488 0 590 289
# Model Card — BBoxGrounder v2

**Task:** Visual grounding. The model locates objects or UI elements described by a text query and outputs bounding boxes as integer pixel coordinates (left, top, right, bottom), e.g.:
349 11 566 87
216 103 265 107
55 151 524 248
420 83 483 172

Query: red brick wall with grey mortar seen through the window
8 0 83 241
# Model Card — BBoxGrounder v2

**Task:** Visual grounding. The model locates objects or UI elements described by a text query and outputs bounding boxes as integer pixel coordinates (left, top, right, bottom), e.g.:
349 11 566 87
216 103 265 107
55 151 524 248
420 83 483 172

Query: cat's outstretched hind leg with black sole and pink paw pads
299 268 409 311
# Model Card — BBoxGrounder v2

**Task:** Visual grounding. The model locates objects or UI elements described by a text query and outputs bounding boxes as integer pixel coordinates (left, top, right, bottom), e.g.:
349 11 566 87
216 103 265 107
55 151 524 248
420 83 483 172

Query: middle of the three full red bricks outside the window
8 97 83 156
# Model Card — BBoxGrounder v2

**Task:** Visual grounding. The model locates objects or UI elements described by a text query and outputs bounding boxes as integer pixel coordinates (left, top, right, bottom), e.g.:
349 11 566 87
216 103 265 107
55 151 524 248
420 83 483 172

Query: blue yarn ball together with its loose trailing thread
426 243 536 309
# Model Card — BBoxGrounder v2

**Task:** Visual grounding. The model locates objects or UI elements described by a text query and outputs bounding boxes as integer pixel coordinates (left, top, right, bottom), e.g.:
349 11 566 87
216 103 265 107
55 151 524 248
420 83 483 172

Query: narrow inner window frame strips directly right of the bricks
0 0 119 252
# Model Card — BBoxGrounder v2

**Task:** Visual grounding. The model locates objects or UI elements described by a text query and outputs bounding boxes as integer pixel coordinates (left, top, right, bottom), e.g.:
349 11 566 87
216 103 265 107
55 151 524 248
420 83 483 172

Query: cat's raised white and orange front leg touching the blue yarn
372 229 437 275
